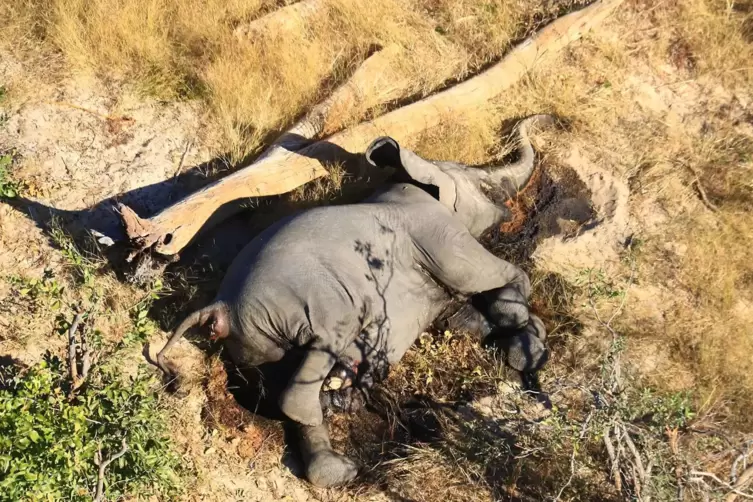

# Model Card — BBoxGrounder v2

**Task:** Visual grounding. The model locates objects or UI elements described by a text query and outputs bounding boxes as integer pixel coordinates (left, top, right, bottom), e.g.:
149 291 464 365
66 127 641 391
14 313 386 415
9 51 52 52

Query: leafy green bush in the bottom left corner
0 357 179 501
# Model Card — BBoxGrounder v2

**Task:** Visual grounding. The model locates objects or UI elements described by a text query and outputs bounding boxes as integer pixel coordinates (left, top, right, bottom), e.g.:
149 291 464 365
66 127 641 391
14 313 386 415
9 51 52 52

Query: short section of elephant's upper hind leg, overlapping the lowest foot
280 345 337 426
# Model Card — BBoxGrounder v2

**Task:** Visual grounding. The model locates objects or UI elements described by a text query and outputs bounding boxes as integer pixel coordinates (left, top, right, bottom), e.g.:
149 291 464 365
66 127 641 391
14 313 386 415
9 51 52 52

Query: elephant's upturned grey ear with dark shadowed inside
365 136 457 211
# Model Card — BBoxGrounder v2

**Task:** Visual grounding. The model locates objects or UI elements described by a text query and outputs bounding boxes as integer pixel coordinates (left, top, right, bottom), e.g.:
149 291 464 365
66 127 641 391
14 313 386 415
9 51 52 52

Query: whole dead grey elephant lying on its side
158 115 551 486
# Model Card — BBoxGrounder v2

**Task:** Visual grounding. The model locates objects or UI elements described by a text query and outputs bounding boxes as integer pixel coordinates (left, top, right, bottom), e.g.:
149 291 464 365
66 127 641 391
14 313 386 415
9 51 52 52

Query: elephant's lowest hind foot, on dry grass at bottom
298 423 358 488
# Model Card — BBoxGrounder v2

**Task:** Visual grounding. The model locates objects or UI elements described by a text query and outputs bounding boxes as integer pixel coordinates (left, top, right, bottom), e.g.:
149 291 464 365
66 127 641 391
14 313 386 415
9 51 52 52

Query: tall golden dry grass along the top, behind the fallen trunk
0 0 552 159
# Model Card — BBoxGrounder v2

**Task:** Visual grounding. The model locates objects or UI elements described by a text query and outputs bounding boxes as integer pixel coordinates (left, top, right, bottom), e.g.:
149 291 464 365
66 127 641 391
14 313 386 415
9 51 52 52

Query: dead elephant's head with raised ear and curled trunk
365 115 554 237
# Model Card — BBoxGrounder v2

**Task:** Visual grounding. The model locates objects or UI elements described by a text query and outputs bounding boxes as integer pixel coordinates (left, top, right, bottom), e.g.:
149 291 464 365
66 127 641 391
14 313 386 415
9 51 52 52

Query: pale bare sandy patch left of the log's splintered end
0 69 212 245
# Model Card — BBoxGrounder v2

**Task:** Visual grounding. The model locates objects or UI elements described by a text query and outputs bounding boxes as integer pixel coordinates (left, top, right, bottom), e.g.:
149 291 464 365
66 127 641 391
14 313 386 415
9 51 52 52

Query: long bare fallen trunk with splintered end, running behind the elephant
114 0 622 258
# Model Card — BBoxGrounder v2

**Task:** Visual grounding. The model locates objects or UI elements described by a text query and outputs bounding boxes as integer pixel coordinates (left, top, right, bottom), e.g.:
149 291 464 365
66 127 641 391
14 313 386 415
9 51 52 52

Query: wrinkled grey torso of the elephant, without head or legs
218 185 453 363
